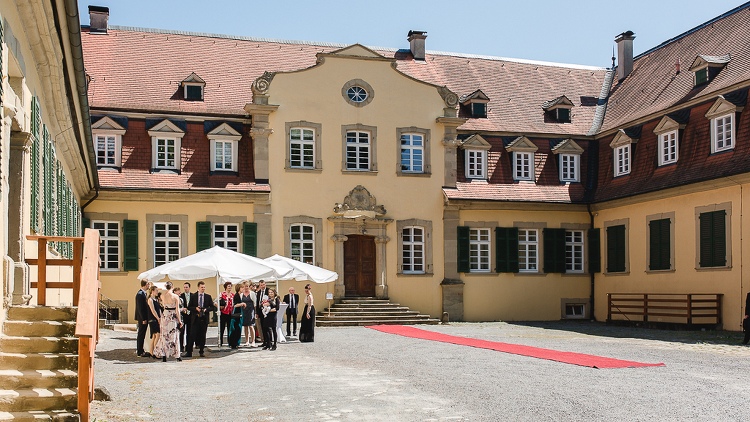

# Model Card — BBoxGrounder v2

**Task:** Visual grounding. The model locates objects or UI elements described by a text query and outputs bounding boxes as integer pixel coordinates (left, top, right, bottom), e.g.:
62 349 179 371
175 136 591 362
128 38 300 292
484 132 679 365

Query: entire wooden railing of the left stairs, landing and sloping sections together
26 229 101 421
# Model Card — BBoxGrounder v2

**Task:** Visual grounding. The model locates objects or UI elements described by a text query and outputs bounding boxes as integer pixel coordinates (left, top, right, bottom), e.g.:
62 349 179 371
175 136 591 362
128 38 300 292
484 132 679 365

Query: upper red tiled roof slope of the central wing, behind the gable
82 27 605 135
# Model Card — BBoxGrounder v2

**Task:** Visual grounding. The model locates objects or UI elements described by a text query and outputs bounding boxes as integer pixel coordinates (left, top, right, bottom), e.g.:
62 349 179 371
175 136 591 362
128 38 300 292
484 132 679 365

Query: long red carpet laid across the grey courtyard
367 325 664 369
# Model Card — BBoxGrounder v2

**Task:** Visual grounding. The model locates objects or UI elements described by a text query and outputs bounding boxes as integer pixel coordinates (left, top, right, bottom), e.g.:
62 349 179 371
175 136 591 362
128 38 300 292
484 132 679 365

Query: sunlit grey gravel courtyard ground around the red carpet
92 322 750 421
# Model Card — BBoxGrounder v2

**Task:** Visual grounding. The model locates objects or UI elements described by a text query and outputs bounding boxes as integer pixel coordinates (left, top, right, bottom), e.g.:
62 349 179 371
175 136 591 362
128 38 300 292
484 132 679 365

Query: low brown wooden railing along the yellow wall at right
607 293 723 325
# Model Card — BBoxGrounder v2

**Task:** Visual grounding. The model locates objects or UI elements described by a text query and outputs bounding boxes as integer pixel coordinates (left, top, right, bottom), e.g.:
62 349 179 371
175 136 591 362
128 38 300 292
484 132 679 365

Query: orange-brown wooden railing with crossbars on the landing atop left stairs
26 232 84 306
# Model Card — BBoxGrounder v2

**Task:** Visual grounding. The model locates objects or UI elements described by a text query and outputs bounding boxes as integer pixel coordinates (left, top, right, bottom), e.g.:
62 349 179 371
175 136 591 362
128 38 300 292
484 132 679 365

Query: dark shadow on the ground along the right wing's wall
508 320 742 346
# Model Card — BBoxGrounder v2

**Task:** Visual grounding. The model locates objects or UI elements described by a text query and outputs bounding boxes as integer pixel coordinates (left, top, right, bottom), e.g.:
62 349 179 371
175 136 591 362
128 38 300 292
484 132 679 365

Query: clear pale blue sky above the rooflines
78 0 750 67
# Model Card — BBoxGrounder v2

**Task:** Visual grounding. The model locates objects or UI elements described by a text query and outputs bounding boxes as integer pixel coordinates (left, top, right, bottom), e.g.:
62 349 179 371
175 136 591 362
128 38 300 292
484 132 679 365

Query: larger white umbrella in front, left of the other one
138 246 291 352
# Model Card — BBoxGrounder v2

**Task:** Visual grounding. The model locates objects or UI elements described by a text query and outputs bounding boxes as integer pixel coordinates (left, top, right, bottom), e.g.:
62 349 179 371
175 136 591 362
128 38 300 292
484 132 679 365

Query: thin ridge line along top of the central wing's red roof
104 25 607 70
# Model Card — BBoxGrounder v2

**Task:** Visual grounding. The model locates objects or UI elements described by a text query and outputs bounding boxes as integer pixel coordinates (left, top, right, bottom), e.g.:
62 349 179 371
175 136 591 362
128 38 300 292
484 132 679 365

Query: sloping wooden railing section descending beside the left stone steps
76 229 101 421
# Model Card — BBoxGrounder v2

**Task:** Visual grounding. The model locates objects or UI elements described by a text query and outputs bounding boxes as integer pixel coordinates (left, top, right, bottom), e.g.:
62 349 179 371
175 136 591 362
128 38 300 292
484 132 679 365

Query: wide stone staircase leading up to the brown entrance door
315 297 440 327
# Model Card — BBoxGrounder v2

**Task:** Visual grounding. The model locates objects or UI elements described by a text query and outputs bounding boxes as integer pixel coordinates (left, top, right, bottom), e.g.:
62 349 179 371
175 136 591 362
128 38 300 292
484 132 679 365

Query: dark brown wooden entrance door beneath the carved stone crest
344 235 382 297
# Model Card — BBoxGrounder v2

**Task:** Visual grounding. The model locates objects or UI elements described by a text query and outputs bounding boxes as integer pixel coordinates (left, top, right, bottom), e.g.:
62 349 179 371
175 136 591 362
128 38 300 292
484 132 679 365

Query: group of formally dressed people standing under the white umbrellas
135 280 315 362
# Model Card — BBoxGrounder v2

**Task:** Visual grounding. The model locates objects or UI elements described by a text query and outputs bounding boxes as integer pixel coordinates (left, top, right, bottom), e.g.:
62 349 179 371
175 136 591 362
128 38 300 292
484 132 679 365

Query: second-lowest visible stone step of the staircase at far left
0 388 78 412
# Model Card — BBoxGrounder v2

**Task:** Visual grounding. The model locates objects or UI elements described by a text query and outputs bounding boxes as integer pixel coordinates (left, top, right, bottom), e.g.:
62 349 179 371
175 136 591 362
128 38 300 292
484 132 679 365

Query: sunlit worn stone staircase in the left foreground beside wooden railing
0 306 79 421
